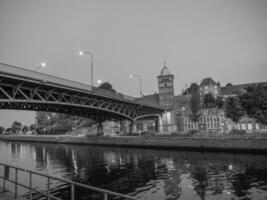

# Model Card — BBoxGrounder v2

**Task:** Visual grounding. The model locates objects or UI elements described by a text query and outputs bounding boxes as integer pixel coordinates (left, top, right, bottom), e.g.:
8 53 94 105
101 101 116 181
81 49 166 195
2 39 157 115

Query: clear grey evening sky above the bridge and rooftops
0 0 267 127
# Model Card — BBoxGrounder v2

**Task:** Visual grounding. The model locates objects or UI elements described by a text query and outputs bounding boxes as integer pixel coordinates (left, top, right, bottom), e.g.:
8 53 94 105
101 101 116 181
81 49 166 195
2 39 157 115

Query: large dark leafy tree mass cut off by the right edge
240 84 267 124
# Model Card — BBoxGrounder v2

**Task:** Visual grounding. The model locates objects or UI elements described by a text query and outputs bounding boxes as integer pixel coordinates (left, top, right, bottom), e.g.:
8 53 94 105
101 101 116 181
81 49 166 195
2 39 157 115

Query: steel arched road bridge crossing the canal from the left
0 63 164 134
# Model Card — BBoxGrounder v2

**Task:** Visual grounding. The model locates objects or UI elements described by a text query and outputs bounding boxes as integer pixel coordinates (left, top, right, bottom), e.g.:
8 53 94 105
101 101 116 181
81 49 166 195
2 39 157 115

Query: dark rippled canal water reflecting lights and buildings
0 141 267 200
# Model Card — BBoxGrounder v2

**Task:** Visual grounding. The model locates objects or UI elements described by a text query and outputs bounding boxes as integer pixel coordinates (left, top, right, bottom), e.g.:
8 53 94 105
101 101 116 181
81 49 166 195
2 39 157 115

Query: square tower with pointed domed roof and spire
158 61 174 108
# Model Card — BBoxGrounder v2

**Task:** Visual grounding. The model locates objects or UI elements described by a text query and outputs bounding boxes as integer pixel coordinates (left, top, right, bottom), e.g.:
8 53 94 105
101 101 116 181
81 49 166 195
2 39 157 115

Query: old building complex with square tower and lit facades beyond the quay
136 63 267 134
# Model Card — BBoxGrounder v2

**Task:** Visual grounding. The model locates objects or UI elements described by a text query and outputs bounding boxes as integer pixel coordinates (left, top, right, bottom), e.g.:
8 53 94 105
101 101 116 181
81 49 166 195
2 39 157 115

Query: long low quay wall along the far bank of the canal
0 135 267 153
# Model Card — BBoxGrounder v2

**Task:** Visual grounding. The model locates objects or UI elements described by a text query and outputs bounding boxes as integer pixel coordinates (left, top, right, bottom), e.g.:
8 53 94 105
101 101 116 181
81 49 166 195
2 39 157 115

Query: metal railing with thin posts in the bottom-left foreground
0 163 137 200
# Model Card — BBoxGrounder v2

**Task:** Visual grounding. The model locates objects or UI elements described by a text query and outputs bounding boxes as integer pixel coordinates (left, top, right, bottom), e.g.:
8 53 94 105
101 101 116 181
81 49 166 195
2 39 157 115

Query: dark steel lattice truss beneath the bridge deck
0 73 163 122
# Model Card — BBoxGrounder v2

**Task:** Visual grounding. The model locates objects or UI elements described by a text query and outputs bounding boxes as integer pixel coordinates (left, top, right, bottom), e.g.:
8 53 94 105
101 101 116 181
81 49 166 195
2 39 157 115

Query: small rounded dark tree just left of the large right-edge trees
225 97 245 123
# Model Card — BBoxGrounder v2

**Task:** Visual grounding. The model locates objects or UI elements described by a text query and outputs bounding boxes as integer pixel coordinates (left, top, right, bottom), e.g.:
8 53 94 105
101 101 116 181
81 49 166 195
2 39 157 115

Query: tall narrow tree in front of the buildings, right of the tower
190 83 201 123
